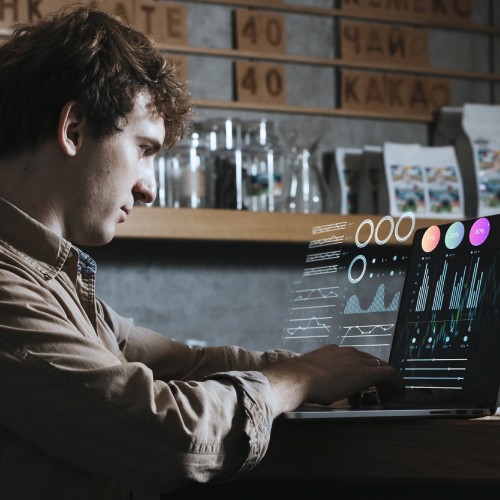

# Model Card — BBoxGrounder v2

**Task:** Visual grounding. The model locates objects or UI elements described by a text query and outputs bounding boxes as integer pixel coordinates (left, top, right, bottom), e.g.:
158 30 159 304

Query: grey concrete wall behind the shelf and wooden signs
93 0 500 349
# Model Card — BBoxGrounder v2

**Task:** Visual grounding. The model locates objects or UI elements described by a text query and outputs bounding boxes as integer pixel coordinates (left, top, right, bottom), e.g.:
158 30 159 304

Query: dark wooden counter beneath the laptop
168 417 500 500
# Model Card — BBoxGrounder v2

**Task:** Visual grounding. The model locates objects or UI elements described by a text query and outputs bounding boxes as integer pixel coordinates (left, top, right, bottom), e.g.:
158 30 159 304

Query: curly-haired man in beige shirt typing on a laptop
0 7 401 500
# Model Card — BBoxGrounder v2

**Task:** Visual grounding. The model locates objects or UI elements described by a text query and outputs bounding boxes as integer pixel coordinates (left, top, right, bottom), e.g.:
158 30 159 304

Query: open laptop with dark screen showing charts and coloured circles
283 215 500 420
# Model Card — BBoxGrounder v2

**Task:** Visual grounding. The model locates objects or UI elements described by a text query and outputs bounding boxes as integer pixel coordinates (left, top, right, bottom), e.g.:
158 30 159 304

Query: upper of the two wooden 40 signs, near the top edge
236 10 285 53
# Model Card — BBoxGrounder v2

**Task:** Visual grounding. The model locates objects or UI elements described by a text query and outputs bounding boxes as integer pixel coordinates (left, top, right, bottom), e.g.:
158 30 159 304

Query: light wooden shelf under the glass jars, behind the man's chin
116 207 442 244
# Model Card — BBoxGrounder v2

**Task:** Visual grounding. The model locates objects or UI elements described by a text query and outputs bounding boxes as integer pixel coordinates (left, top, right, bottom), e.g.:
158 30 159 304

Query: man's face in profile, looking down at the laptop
63 94 165 246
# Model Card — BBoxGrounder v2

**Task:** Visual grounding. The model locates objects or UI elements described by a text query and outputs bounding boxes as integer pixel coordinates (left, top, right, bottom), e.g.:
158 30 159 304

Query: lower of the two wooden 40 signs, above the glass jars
236 61 286 104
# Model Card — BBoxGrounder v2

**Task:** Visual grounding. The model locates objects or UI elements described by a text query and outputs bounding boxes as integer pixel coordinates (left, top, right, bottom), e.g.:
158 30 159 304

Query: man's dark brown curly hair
0 5 192 157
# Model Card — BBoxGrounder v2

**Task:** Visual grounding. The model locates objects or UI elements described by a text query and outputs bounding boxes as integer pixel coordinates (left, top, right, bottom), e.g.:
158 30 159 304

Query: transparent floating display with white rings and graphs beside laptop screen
283 212 415 360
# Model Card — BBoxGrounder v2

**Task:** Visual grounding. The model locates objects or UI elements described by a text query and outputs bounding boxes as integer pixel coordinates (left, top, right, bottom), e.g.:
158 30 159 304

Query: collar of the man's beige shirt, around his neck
0 198 74 279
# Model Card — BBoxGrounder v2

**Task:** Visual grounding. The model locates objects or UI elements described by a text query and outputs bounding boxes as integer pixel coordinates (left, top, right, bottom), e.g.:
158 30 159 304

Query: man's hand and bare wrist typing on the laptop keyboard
263 344 404 416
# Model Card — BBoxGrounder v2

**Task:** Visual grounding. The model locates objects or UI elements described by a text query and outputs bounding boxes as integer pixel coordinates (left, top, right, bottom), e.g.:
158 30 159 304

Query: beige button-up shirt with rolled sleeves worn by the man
0 199 292 500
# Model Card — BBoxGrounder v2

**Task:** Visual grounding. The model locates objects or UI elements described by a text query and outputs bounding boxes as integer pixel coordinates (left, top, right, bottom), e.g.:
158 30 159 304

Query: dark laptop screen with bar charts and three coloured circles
391 216 500 393
